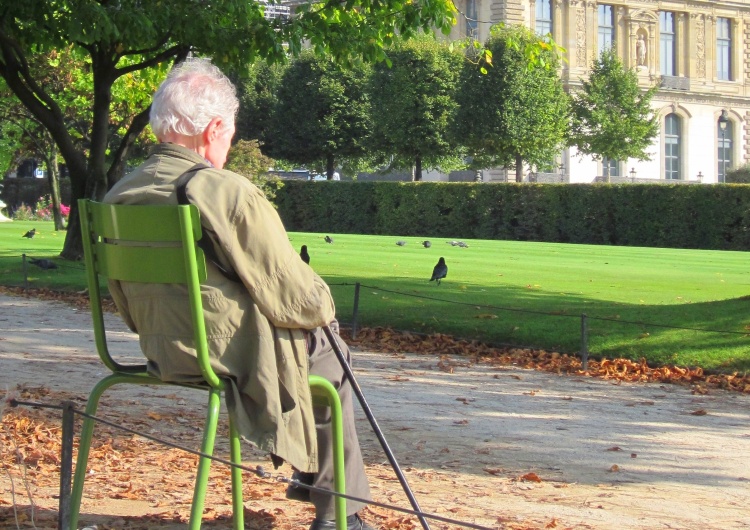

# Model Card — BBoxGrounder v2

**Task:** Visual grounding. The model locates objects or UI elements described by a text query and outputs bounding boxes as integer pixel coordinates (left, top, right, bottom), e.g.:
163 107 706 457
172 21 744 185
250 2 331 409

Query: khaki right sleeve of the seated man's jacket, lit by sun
200 175 335 329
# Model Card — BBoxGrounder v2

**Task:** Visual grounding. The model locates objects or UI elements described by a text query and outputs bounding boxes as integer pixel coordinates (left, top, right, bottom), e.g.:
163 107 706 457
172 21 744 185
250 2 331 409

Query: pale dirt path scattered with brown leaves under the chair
0 295 750 530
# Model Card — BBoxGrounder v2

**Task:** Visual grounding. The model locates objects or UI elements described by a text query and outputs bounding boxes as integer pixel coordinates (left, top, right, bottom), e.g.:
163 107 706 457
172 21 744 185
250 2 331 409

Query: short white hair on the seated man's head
149 58 240 139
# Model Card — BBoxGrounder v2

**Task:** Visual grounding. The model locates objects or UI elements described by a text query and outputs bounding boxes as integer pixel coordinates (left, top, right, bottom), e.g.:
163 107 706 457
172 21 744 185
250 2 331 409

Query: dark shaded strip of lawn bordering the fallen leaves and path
332 279 750 373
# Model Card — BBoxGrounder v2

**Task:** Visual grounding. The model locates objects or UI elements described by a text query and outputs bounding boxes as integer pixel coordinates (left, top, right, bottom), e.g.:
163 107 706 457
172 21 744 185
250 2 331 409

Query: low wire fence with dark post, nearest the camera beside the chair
9 399 500 530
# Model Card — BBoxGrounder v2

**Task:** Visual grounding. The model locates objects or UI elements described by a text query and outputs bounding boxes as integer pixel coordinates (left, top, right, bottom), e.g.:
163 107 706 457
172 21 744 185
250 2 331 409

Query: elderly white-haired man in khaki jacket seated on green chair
104 59 373 530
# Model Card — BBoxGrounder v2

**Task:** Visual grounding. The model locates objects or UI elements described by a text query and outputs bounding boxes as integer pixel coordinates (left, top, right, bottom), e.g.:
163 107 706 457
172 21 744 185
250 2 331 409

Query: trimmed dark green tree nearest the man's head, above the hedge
263 51 371 178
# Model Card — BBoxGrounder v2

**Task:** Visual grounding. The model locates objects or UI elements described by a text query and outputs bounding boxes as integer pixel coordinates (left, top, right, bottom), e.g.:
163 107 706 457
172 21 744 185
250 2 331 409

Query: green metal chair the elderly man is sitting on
70 199 346 530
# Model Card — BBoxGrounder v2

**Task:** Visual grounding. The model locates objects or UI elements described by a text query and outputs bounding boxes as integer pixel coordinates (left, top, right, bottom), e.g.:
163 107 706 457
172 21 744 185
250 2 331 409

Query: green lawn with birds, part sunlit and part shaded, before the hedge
0 222 750 372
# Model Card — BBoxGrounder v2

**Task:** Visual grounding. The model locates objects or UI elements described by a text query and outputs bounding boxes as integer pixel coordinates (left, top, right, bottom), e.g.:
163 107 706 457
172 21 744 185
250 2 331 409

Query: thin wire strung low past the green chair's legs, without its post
8 399 500 530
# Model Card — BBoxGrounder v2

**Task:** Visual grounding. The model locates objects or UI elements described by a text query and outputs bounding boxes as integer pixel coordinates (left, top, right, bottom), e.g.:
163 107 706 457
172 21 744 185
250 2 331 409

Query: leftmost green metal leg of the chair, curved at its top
66 374 159 530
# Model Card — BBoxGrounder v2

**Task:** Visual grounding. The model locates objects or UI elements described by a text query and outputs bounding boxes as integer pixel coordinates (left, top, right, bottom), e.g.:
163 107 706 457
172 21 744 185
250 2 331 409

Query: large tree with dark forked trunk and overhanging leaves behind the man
0 0 455 258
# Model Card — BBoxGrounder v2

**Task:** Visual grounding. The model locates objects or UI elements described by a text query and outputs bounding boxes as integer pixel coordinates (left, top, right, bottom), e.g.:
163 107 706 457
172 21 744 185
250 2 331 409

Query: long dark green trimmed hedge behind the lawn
276 181 750 250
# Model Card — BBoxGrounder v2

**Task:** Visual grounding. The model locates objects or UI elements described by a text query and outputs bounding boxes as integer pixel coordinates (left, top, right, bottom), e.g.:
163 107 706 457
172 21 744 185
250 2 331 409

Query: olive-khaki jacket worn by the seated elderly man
104 144 335 472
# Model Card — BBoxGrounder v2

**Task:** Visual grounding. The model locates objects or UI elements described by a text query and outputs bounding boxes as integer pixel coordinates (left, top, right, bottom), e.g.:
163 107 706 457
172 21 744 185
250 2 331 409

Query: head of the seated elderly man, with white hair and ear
150 59 239 169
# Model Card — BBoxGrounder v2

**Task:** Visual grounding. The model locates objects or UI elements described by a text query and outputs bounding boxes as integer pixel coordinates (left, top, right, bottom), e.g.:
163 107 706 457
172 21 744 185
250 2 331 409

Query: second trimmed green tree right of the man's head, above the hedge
369 36 464 180
